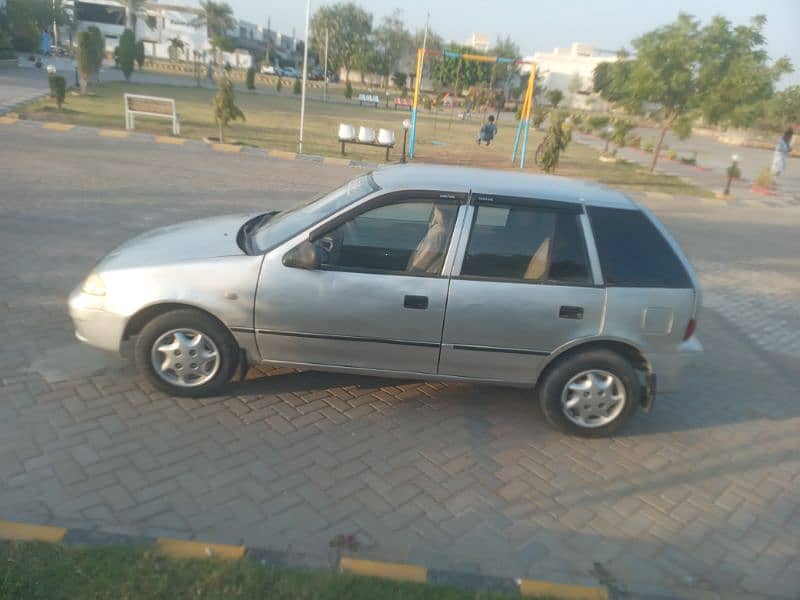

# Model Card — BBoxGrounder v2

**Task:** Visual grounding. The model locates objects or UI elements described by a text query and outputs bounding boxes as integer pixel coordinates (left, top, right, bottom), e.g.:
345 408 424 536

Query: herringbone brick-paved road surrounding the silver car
0 123 800 598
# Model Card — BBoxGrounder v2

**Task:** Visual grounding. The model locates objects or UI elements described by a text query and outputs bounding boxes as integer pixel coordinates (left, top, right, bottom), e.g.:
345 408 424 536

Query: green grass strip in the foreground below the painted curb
0 542 520 600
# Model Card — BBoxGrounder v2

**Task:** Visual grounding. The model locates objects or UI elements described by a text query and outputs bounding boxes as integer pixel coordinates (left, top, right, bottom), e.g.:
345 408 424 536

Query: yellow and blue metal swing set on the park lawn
408 48 536 169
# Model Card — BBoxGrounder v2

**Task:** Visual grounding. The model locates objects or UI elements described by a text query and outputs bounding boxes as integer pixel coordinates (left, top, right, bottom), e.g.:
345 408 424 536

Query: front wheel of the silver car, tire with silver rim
134 309 239 397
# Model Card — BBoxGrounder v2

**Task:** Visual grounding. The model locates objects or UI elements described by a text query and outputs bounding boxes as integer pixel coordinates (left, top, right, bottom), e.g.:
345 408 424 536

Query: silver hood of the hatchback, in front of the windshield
100 214 255 269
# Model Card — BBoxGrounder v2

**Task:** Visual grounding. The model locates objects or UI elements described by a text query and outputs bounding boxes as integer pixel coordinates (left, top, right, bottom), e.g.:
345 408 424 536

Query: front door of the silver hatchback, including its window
255 192 465 374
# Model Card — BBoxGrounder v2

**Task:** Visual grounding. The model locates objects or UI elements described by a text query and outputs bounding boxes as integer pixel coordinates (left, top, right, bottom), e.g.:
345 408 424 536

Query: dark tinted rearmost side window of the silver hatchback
587 207 692 288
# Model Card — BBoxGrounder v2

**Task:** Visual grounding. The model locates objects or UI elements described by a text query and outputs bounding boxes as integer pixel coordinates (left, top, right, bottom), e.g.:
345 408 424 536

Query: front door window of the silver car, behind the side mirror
315 200 458 275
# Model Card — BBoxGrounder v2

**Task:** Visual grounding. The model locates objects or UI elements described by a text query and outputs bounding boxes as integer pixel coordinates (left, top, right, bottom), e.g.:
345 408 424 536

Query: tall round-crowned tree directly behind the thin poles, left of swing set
311 2 372 81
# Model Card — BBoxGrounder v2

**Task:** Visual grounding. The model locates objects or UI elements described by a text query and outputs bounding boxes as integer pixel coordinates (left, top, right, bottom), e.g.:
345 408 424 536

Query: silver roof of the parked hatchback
372 165 639 209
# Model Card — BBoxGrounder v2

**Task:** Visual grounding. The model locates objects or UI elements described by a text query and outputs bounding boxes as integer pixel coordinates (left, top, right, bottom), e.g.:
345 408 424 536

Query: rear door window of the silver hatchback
461 205 591 284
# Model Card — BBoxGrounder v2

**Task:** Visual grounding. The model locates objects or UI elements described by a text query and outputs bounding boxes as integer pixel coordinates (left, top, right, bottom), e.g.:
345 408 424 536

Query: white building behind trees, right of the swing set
521 42 617 110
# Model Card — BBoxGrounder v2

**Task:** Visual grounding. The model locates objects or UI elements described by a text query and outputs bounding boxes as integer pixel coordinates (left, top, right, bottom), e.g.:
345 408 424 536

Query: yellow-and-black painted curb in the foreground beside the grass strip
0 520 609 600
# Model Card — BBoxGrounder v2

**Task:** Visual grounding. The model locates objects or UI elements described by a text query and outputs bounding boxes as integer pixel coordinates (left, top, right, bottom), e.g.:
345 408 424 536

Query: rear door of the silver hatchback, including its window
439 195 604 383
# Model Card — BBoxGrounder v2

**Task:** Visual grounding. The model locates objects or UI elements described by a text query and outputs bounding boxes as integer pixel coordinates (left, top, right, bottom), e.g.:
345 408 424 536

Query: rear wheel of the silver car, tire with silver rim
538 350 642 438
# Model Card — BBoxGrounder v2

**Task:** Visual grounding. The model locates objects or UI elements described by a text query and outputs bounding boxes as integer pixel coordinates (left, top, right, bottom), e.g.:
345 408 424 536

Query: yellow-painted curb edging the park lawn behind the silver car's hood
0 113 378 169
